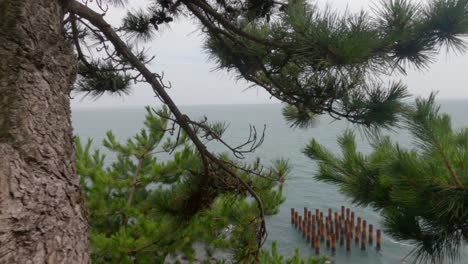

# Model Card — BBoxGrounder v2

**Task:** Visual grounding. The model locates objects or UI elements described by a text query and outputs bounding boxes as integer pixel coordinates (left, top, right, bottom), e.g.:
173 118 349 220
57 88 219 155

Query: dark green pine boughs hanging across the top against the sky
75 0 468 129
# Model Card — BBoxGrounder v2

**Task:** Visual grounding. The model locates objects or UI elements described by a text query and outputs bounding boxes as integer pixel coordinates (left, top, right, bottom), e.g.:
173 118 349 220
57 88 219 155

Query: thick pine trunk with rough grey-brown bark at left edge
0 0 89 264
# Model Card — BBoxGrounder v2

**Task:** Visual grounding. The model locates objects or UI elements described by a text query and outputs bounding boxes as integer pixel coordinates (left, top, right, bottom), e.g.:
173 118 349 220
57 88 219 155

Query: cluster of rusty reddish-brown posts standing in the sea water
291 206 382 254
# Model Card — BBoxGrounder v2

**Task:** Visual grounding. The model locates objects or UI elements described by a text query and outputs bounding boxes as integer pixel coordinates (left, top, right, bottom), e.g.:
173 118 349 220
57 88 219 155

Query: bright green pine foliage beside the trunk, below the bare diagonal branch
76 108 290 263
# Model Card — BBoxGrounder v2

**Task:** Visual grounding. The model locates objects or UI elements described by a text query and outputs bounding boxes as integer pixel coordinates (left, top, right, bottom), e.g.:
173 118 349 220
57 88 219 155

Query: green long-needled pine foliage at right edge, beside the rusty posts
304 95 468 263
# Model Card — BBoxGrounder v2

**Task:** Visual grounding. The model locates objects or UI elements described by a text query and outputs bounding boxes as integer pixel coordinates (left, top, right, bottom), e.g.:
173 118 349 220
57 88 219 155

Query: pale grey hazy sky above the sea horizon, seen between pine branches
72 0 468 108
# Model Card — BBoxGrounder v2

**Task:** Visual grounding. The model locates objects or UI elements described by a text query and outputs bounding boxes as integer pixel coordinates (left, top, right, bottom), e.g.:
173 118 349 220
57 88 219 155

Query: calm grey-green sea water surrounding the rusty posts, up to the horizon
72 100 468 264
